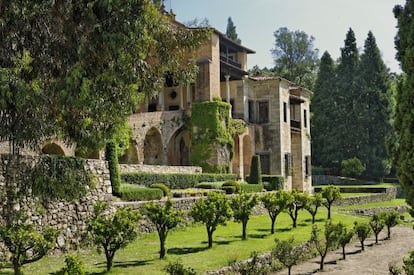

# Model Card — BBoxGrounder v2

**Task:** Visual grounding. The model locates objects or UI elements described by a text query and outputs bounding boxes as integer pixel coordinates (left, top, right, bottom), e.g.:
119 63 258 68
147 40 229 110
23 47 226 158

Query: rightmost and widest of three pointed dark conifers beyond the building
355 32 391 177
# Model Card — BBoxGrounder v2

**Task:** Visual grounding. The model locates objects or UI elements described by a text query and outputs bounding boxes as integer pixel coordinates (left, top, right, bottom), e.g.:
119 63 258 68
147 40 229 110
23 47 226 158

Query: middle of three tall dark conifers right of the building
325 29 360 168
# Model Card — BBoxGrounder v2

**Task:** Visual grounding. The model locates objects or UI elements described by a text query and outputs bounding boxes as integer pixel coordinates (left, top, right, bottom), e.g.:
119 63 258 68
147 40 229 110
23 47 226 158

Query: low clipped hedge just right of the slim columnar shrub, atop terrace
120 183 163 201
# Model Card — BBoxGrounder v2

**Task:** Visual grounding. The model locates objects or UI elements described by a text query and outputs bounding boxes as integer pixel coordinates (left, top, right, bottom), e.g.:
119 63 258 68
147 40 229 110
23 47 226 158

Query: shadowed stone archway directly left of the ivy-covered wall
168 128 190 166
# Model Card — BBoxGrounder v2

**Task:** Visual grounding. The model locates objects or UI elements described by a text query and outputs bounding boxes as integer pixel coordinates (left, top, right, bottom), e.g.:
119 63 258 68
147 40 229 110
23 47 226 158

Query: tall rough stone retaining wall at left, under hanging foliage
0 155 112 258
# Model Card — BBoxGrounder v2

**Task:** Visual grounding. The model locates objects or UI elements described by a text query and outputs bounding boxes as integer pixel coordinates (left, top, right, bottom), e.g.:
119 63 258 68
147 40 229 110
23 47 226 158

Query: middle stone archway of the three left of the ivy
144 127 163 165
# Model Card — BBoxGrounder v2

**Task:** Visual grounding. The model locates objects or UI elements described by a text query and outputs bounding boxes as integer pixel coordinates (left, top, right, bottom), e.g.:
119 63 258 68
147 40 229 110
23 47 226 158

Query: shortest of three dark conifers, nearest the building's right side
311 52 336 167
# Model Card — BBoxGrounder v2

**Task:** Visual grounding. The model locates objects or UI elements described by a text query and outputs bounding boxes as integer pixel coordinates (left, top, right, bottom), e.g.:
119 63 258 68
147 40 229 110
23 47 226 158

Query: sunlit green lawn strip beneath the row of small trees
0 208 365 275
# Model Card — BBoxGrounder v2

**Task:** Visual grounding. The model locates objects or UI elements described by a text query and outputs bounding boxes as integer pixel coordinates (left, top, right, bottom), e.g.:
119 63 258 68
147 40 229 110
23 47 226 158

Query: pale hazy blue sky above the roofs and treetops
165 0 405 72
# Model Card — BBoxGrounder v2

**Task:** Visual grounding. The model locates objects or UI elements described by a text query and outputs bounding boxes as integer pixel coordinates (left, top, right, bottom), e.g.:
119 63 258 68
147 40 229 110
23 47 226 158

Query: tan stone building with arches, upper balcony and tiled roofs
0 22 312 192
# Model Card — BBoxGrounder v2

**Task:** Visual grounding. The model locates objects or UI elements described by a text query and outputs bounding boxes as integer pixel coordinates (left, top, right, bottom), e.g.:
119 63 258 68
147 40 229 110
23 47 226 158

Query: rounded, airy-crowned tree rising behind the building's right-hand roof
272 27 318 88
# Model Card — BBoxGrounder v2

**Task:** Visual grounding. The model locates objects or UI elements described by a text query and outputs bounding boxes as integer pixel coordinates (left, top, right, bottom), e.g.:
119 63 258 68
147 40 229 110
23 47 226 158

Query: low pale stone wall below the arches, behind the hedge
119 164 203 174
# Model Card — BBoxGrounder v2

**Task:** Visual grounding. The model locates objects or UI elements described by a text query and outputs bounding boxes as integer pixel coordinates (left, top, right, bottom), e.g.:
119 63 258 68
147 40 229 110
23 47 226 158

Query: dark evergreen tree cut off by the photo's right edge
393 0 414 211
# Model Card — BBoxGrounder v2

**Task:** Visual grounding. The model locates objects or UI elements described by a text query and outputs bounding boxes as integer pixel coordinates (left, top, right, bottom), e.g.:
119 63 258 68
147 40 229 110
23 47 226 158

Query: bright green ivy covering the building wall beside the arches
190 101 234 173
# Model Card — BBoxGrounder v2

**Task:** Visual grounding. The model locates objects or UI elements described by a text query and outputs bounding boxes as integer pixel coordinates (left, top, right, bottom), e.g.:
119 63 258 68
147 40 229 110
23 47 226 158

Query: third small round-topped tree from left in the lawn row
145 200 183 259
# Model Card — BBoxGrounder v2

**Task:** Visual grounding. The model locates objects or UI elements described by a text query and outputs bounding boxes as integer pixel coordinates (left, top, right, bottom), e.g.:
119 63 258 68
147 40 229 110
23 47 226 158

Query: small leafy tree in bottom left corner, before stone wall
0 212 58 275
